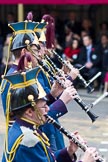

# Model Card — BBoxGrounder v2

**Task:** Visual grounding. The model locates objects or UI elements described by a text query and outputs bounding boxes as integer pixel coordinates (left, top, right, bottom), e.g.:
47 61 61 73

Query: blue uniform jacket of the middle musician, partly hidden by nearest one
1 64 67 151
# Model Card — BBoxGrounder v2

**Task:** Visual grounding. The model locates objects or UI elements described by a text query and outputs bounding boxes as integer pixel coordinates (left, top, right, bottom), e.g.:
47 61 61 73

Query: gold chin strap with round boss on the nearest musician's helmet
28 95 45 125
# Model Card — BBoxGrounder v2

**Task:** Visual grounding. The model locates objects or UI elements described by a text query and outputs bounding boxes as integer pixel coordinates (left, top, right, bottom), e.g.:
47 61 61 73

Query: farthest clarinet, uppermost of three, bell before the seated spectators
49 50 94 92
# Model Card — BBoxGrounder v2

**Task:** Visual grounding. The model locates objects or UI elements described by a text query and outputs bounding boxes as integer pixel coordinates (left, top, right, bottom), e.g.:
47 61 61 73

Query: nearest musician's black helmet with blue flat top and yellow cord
4 67 46 112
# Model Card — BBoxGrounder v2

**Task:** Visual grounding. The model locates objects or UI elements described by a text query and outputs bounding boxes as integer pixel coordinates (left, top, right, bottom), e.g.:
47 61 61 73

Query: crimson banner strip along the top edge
0 0 108 5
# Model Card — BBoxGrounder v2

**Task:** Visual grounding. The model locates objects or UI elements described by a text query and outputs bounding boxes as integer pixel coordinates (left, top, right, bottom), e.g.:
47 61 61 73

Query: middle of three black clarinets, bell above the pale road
38 57 98 122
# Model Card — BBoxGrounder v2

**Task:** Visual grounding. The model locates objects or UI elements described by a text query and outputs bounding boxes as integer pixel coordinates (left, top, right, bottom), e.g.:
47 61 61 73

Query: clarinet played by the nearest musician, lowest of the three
45 115 104 162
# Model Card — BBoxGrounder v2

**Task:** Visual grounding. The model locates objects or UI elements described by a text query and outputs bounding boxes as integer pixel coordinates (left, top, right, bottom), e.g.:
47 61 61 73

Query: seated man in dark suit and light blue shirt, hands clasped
79 35 101 90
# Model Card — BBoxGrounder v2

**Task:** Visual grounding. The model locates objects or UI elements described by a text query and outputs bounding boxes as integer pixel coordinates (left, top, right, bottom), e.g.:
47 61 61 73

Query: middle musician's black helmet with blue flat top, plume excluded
9 21 39 51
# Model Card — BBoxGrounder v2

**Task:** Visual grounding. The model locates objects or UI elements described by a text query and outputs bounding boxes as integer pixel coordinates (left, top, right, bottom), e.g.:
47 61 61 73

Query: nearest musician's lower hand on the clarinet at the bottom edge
81 147 99 162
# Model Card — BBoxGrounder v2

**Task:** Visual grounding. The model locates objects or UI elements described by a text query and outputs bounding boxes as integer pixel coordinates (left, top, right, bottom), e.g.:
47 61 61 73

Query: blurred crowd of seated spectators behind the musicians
0 12 108 91
